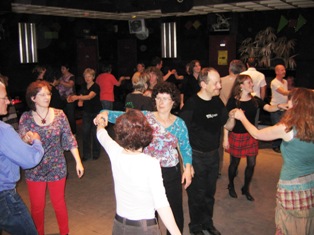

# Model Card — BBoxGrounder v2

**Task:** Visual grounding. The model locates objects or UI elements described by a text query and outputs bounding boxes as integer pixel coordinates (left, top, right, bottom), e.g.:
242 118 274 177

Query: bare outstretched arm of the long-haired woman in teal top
234 109 293 141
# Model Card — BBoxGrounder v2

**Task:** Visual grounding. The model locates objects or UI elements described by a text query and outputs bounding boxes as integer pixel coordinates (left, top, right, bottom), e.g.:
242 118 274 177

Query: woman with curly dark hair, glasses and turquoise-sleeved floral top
97 82 192 233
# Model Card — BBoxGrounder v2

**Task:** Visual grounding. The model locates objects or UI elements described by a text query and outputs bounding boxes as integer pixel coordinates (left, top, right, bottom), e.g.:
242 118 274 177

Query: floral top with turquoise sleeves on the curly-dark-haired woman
108 111 192 167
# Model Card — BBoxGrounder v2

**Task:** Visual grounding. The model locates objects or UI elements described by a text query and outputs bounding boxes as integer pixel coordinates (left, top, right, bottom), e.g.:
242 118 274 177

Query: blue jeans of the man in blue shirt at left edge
0 189 38 235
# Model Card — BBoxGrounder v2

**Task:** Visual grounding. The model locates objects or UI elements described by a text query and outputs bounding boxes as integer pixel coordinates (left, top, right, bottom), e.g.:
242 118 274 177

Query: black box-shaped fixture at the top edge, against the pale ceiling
160 0 193 13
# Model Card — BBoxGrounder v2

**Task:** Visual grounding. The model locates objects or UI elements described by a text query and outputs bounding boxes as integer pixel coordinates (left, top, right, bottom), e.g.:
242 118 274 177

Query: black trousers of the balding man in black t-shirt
187 149 219 232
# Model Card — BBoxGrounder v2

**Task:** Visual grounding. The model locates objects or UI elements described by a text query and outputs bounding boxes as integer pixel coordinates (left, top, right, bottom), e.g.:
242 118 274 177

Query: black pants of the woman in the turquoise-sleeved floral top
161 163 184 235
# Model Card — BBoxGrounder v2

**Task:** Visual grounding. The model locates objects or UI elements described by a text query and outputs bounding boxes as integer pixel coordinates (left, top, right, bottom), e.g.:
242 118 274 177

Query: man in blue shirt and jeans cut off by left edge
0 78 44 235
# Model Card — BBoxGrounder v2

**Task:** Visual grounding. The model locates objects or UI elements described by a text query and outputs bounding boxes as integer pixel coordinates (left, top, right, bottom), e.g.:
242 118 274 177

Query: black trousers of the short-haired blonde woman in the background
83 112 100 159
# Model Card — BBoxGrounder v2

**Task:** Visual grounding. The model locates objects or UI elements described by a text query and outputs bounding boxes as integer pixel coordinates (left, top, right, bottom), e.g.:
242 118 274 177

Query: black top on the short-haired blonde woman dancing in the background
82 83 102 113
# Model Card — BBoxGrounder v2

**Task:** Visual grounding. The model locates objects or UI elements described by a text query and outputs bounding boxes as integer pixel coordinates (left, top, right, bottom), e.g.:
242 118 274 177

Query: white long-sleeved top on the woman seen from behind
97 129 169 220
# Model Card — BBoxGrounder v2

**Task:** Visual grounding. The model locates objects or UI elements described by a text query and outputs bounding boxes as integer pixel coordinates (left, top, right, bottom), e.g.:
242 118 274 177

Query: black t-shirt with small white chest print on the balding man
180 95 228 152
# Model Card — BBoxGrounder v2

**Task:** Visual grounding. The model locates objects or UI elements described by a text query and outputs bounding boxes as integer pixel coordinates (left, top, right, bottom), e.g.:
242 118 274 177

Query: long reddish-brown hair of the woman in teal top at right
279 88 314 142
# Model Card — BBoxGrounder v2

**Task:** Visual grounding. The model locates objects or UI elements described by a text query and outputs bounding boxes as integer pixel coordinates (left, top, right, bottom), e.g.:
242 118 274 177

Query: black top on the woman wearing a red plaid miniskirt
227 96 266 133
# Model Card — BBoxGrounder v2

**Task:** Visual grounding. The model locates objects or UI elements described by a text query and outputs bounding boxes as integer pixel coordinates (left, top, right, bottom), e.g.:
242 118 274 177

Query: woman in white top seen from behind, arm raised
94 109 181 235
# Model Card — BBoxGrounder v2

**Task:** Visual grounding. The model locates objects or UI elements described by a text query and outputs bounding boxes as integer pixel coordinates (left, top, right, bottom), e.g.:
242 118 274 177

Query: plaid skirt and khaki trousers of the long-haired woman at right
275 174 314 235
